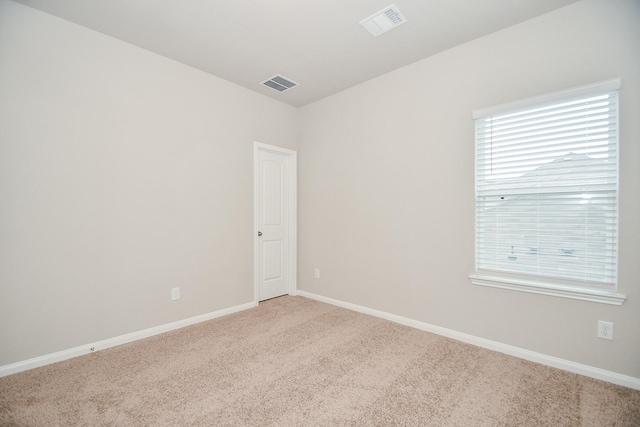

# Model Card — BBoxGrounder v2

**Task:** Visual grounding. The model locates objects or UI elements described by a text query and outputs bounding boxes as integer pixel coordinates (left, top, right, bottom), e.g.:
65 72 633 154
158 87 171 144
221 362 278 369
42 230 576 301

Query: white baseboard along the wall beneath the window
296 290 640 390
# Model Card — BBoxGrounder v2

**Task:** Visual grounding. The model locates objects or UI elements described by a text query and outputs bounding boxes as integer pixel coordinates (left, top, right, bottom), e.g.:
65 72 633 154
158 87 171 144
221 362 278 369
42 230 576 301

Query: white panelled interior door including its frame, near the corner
254 143 296 301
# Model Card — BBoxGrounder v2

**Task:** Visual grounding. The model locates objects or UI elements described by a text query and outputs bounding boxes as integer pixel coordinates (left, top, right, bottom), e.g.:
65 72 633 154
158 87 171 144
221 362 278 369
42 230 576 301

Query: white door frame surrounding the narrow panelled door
253 142 298 306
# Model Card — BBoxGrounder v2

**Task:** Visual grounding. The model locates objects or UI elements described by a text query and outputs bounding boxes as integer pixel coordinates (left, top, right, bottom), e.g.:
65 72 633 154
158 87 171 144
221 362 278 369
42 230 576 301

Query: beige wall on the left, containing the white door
0 0 298 366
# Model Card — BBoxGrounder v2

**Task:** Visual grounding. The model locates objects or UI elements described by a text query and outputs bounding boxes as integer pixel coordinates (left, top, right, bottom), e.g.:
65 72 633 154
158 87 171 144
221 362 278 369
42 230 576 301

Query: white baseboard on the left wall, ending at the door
0 302 256 377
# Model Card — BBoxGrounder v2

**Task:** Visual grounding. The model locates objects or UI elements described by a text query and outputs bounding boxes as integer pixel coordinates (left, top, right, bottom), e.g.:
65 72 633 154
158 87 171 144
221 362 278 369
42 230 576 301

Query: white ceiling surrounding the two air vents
14 0 578 107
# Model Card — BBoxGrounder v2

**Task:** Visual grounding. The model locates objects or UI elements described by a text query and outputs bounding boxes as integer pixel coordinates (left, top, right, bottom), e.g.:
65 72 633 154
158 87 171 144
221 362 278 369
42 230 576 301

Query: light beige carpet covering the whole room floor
0 297 640 427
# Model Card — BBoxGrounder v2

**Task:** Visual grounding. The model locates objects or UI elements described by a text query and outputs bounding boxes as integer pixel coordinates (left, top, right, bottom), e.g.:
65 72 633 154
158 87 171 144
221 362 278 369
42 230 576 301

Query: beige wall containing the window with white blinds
298 0 640 377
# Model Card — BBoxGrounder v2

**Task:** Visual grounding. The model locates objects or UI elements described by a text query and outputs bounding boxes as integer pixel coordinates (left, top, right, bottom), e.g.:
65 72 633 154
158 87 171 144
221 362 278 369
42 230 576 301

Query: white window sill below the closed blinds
469 274 626 305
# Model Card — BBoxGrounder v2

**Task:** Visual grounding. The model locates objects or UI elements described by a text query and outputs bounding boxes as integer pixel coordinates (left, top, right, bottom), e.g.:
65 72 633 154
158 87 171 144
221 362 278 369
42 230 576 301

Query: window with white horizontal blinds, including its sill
471 79 624 304
